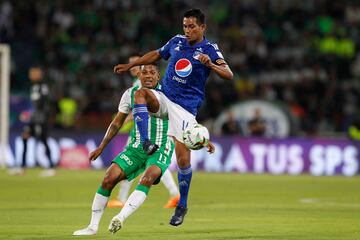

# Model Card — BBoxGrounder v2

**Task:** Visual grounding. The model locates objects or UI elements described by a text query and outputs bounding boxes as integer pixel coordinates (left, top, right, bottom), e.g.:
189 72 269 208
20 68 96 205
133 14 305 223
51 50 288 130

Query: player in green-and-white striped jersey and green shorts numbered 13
73 62 174 235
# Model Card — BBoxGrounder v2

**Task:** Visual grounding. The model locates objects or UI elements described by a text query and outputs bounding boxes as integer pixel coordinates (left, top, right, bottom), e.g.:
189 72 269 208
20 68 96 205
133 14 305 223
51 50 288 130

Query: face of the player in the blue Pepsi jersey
183 17 205 44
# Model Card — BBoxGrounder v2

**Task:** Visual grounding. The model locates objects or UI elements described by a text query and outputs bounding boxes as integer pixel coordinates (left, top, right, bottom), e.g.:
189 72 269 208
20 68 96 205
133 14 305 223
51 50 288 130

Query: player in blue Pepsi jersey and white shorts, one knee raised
114 9 233 226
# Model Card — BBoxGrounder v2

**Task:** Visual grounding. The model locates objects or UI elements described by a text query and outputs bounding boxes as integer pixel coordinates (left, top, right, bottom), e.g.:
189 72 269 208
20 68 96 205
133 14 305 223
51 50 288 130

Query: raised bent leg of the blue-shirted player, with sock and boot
132 88 159 155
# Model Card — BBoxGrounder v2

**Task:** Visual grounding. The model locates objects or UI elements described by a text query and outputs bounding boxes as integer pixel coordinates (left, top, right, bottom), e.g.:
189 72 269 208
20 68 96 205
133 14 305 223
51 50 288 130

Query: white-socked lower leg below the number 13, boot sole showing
109 165 161 234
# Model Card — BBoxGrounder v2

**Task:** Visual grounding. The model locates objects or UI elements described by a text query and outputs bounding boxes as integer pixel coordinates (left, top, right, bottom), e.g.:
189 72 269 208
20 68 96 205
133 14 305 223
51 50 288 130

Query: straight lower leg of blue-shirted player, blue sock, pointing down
170 138 192 226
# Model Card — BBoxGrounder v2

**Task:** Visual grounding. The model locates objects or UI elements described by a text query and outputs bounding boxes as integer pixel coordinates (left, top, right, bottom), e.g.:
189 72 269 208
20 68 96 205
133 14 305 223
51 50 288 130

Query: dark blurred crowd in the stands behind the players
0 0 360 134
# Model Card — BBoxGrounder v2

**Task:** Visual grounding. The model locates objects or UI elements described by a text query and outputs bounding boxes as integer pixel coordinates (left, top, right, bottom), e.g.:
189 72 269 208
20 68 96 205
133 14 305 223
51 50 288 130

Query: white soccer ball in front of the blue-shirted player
183 123 210 150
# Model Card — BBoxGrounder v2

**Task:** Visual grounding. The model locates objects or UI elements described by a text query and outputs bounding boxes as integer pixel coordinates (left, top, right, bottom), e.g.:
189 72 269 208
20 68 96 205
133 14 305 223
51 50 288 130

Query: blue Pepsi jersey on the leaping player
159 35 223 116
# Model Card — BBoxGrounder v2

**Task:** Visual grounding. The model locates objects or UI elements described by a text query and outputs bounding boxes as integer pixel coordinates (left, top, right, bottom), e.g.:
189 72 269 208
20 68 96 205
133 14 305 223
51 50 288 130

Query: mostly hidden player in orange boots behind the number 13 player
107 54 180 208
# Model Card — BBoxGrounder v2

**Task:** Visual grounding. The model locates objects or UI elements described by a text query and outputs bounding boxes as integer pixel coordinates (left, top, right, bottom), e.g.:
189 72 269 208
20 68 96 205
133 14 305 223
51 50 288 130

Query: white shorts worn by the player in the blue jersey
151 89 197 143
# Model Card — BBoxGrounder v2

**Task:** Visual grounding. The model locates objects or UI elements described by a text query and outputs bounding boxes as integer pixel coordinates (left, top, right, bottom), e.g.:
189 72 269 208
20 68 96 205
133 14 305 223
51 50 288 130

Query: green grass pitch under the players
0 170 360 240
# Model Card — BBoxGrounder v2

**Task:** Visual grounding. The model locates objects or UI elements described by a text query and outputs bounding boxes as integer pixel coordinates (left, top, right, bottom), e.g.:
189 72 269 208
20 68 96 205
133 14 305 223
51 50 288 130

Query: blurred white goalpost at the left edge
0 44 10 168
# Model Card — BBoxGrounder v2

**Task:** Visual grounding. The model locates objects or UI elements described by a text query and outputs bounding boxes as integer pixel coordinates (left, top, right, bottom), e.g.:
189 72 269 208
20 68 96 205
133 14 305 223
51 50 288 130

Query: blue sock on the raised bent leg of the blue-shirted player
132 104 149 143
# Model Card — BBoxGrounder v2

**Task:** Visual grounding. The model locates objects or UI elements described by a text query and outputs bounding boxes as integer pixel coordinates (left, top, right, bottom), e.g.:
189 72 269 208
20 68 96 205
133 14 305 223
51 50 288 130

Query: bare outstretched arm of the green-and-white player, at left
89 112 127 161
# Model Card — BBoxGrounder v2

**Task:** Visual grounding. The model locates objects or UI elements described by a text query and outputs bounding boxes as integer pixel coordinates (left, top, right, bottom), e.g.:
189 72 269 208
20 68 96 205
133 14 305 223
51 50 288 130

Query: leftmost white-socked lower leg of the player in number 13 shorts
73 163 125 236
